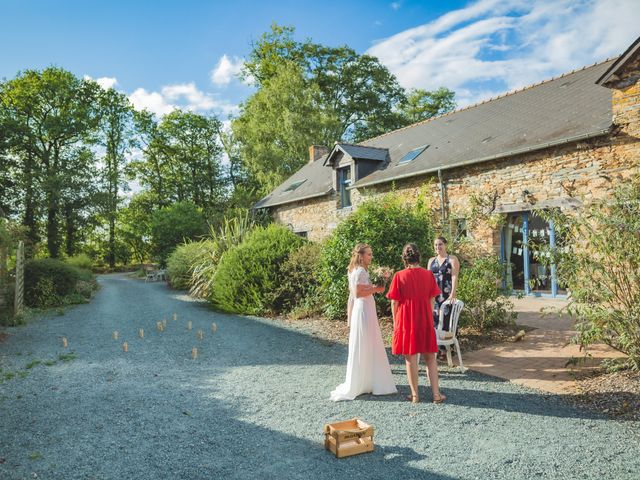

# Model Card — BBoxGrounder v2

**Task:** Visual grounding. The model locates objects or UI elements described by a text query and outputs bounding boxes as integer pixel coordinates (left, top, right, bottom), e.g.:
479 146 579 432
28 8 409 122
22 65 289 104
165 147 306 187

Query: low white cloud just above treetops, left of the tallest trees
129 82 239 117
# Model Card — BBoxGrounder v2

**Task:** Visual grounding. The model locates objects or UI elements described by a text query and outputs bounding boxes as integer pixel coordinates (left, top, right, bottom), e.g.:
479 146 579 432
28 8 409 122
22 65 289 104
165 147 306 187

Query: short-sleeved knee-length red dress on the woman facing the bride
387 267 440 355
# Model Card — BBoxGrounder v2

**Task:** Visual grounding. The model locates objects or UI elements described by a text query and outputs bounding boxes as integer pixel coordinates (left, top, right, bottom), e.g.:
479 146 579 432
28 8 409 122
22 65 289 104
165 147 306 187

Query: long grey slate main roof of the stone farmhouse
254 59 615 208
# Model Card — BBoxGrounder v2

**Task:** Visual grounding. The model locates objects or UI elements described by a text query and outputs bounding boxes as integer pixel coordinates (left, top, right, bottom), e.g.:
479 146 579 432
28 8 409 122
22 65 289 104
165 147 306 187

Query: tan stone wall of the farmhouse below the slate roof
274 78 640 253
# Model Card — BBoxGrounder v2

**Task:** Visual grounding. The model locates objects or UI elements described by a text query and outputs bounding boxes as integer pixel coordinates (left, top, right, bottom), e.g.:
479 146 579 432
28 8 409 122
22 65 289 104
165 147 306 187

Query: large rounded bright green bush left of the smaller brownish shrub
209 225 305 315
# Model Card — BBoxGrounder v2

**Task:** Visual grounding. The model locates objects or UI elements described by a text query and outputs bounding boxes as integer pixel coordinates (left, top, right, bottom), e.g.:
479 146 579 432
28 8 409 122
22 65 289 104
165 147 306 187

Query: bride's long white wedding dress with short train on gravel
331 267 397 402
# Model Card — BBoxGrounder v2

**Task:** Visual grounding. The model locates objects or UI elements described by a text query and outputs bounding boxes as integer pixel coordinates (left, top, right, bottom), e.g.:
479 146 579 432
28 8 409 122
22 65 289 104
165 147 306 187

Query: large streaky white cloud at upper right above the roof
367 0 640 106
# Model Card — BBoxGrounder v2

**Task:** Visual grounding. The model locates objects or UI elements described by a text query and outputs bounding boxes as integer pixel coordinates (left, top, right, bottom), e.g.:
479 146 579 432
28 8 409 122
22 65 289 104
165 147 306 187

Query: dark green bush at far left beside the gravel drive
24 258 97 308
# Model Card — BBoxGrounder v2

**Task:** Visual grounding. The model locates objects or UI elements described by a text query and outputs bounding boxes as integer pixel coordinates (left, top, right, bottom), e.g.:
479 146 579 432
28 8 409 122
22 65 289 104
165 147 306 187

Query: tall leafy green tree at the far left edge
0 67 99 257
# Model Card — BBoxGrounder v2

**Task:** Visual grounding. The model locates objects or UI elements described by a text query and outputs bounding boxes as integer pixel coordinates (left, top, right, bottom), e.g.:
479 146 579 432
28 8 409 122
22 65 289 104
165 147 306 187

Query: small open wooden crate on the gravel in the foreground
324 418 374 458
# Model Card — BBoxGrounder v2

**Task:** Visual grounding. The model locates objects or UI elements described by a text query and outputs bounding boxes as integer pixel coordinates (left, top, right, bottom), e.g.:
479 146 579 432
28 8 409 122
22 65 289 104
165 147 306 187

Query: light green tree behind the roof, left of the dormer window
232 62 336 194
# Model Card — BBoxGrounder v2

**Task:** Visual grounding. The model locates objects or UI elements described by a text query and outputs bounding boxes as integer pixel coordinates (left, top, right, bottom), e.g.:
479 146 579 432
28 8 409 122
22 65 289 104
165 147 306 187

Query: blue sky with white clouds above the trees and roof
0 0 640 120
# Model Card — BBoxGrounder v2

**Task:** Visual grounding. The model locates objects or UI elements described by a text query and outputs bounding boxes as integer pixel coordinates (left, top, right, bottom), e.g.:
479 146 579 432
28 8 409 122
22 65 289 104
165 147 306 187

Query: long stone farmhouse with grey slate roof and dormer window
254 38 640 297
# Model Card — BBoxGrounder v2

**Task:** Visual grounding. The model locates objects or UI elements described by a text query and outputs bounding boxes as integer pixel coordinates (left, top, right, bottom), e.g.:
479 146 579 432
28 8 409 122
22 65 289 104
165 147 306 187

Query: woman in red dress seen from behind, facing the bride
387 243 447 403
